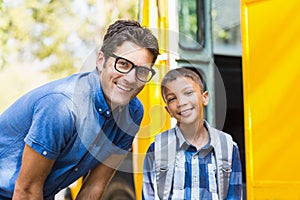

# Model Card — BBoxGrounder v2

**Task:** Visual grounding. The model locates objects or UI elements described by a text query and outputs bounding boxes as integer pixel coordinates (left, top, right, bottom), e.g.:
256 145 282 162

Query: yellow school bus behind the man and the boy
71 0 300 200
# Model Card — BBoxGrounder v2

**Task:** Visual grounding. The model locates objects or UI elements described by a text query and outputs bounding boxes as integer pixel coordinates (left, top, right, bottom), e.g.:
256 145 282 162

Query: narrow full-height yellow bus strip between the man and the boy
133 0 170 200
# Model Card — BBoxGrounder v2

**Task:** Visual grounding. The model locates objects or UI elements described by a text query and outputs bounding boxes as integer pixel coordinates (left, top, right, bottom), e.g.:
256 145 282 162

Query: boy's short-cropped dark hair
160 67 205 101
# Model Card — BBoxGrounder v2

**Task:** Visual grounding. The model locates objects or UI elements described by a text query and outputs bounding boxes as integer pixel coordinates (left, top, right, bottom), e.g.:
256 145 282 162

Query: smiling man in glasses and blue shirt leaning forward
0 20 159 199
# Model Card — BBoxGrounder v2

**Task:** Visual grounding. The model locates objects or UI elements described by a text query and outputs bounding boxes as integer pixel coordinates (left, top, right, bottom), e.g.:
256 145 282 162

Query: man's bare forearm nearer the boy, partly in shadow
76 155 126 200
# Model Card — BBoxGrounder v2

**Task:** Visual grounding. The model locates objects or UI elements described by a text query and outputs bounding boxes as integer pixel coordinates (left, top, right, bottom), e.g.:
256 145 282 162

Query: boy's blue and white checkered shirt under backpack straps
142 125 242 200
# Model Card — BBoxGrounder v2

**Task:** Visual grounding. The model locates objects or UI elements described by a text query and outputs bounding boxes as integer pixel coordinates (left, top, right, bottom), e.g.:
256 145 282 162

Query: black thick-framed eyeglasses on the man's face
110 53 155 83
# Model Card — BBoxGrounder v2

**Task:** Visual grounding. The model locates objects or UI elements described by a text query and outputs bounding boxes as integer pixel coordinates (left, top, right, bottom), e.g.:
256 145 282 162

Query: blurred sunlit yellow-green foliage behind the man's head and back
0 0 138 76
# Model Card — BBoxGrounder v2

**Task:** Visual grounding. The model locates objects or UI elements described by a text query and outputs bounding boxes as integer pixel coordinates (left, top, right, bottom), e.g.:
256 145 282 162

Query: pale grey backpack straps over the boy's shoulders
154 124 234 200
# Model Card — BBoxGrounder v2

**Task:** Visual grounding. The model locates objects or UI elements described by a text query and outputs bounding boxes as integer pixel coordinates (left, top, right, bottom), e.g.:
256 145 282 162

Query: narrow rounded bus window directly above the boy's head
178 0 204 49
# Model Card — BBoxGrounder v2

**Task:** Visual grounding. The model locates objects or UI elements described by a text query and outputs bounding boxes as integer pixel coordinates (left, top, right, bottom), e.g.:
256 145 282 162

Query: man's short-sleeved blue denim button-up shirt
0 69 144 199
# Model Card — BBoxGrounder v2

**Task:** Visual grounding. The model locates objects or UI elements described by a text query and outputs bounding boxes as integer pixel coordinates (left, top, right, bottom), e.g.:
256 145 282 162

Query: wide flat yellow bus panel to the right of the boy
241 0 300 199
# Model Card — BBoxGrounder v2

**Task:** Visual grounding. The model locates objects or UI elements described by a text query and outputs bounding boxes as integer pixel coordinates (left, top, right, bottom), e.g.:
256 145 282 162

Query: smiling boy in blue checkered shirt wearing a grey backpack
142 68 242 200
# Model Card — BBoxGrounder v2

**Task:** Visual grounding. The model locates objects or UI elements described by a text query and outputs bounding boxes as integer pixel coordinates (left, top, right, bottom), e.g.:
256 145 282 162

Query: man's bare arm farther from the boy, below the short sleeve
13 144 55 200
